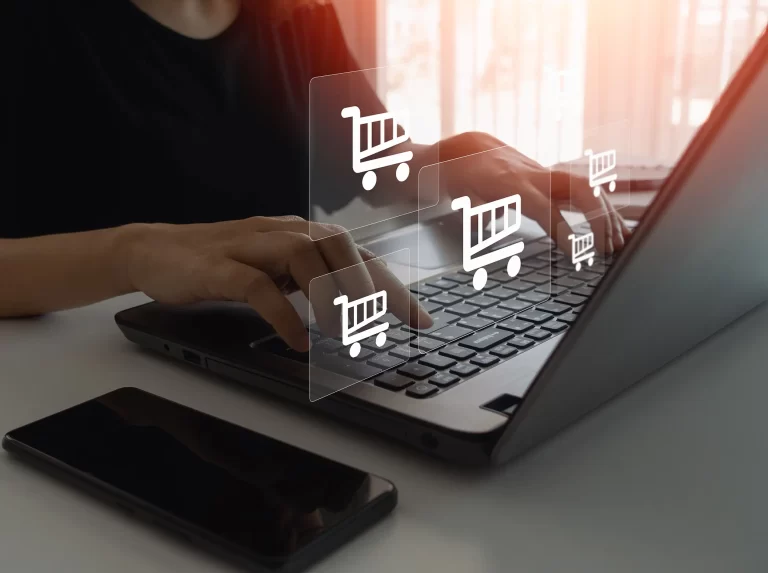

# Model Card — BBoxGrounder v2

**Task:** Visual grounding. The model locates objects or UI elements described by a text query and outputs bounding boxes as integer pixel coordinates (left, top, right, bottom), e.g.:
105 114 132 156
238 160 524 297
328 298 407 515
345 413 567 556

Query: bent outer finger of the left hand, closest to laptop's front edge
205 259 309 352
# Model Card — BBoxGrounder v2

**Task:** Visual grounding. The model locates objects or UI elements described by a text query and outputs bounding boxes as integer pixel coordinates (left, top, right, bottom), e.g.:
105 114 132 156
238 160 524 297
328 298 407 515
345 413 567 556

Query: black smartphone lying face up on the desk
3 388 397 573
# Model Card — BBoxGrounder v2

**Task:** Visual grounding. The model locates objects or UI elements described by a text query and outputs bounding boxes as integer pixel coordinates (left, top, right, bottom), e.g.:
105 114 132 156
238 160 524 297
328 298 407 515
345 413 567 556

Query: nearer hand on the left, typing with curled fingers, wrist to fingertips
120 217 432 352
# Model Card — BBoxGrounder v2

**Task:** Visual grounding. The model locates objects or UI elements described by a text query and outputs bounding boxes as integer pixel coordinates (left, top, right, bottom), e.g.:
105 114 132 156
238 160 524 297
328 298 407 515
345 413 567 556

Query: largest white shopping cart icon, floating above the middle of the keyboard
451 195 525 290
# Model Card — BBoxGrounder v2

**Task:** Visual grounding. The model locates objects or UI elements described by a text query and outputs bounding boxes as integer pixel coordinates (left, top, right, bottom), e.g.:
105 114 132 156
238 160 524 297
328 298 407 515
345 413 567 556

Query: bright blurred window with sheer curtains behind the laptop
332 0 768 169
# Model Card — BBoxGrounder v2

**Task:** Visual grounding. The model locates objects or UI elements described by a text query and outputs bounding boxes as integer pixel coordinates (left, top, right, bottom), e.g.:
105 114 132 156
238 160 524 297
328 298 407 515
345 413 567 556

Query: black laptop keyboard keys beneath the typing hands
258 238 612 400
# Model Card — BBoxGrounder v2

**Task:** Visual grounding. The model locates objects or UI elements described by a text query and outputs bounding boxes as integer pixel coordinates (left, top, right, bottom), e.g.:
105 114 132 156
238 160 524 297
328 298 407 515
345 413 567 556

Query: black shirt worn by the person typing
0 0 380 237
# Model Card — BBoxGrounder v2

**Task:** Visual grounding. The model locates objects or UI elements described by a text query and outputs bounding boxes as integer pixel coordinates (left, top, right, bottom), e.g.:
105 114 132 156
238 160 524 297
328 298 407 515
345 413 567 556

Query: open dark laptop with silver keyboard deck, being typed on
116 29 768 465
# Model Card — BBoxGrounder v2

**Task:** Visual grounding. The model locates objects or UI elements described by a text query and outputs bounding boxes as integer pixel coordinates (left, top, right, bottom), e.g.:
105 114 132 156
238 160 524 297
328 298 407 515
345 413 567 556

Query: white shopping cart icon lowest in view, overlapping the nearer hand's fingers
333 290 389 358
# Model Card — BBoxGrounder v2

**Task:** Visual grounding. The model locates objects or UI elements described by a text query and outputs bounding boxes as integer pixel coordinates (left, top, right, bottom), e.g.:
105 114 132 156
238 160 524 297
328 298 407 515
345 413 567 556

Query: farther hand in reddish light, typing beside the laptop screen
428 132 630 255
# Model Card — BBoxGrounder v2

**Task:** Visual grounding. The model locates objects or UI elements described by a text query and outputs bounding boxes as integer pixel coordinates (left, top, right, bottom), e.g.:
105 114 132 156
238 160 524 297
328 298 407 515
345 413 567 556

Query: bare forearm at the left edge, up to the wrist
0 225 134 317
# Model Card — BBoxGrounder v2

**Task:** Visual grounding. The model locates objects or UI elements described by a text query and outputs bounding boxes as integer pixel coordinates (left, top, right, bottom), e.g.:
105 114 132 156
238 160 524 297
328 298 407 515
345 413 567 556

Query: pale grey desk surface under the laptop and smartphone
0 295 768 573
